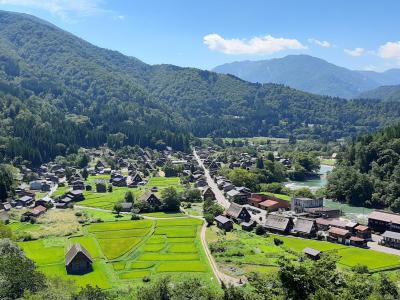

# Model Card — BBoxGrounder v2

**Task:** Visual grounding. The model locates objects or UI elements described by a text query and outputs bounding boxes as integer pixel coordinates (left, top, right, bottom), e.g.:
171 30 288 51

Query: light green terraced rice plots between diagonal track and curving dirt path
114 218 212 280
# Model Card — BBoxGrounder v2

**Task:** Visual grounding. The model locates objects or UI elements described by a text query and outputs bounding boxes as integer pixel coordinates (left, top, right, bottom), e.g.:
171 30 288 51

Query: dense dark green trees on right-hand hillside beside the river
327 125 400 212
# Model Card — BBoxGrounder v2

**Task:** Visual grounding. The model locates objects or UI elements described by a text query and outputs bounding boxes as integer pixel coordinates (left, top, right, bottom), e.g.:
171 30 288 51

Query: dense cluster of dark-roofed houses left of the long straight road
0 147 198 223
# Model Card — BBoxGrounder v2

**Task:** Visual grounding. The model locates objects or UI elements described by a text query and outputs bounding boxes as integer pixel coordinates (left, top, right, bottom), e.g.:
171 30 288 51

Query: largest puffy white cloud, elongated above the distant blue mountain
203 33 307 54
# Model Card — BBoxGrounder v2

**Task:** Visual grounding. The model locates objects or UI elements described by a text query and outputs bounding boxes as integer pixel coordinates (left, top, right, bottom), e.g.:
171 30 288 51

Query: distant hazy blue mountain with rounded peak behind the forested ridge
213 55 400 98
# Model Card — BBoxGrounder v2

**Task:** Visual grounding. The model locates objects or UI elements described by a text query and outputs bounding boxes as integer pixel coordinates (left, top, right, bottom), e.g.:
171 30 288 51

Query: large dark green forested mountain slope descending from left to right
0 12 400 164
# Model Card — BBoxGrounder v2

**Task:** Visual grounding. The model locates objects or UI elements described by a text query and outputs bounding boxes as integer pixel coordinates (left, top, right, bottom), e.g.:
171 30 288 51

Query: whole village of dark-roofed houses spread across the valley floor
0 141 400 286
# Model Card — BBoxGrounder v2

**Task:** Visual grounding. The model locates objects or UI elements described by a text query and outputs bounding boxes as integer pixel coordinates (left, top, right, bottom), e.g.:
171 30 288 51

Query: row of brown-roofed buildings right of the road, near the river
215 193 400 248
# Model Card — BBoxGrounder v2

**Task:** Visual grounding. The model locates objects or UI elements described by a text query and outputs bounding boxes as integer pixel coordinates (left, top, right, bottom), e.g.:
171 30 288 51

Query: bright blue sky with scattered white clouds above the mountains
0 0 400 71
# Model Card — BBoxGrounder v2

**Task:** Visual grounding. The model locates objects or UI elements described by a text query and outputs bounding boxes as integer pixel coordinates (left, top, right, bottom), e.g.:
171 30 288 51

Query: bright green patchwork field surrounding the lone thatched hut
19 218 216 289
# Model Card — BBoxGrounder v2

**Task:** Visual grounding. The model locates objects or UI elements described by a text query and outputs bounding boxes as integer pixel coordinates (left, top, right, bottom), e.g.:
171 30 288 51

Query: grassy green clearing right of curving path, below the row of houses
207 227 400 276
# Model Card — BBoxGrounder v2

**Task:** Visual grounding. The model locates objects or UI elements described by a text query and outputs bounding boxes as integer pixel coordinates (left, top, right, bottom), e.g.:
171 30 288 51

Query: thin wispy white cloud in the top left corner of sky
0 0 108 19
